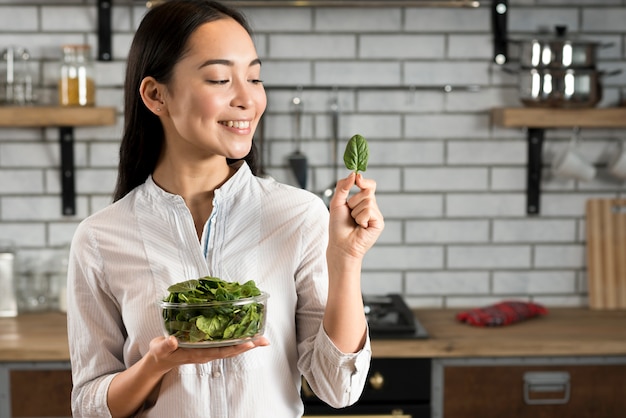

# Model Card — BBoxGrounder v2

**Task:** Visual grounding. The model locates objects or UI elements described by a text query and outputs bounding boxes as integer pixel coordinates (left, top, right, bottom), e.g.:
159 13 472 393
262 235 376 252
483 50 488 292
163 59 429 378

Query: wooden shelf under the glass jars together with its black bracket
0 106 116 215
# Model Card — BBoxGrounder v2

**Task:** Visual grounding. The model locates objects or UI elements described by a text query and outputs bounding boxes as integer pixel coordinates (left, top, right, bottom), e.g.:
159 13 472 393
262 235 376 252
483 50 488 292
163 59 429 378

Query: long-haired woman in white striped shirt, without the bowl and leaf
68 0 383 418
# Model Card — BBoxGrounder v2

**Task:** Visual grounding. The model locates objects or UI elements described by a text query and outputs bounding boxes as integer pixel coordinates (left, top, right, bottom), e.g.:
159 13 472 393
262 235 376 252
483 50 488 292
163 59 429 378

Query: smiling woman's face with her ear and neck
139 15 267 216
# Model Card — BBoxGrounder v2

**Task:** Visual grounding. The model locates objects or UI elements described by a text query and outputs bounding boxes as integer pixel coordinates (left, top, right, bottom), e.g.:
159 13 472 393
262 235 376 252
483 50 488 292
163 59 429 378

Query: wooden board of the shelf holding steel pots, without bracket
491 107 626 128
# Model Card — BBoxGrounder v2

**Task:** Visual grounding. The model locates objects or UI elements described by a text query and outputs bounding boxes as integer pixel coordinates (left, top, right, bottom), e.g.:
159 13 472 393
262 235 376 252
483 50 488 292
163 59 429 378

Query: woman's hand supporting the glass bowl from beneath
148 336 269 373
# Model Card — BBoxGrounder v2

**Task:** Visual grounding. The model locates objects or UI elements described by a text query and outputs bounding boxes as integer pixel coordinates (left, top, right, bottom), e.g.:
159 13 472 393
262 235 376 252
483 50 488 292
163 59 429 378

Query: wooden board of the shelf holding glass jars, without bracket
0 106 116 128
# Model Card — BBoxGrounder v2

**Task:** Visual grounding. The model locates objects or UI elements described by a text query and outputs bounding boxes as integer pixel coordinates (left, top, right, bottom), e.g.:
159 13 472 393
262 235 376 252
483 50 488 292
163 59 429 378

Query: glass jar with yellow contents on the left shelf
59 45 96 106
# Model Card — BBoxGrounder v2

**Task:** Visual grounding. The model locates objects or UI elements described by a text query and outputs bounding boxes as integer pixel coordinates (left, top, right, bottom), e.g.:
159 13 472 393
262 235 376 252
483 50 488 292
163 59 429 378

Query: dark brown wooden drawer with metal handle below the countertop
443 364 626 418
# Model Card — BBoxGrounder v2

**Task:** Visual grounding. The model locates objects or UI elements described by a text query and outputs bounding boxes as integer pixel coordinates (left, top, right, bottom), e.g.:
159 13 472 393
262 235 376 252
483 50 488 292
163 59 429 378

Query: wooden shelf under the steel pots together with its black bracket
491 107 626 215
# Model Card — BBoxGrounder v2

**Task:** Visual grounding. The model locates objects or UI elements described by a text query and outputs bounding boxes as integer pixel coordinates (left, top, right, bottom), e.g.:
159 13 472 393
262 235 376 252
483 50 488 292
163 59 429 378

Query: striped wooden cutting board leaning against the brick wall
585 199 626 309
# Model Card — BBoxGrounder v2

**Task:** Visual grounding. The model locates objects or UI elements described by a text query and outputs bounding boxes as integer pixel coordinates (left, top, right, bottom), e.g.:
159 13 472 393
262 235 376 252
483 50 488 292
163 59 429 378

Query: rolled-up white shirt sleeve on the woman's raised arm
296 200 371 408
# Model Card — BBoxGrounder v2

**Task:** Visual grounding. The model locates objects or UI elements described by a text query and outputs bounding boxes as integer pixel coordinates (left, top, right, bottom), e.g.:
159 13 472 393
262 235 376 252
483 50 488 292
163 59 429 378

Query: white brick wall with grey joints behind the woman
0 0 626 307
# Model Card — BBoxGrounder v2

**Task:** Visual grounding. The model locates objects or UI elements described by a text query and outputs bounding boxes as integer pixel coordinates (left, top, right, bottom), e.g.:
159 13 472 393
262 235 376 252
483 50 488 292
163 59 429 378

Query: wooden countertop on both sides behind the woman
0 308 626 362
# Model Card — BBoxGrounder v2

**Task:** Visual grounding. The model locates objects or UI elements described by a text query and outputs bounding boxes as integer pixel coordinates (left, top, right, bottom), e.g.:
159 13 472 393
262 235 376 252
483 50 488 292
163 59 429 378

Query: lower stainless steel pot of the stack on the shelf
519 68 602 108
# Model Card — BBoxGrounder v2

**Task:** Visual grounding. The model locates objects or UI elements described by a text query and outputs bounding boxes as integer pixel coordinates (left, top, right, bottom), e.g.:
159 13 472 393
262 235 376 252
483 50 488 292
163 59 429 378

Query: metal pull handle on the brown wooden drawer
524 372 570 405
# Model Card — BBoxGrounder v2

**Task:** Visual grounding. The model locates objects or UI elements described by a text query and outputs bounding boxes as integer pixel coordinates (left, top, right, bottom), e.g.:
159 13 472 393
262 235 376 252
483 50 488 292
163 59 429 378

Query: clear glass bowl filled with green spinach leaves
163 276 265 343
